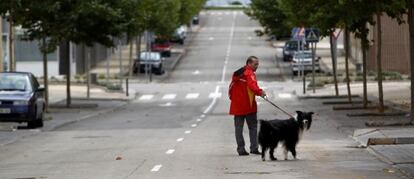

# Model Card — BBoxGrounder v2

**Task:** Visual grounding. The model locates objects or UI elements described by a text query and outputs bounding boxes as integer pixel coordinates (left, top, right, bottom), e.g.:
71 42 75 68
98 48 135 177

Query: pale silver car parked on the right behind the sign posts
291 51 321 75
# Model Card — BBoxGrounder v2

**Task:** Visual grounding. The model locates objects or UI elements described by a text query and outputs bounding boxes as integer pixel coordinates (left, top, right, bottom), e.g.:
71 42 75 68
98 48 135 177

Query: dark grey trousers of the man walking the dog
234 113 258 153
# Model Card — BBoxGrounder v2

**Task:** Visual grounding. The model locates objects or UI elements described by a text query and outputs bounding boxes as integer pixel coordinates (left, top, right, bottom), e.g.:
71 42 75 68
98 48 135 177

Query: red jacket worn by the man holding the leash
229 65 263 115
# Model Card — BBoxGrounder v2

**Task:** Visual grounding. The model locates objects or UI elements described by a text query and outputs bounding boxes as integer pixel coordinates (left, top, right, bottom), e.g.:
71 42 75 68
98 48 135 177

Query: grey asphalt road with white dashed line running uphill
0 11 401 179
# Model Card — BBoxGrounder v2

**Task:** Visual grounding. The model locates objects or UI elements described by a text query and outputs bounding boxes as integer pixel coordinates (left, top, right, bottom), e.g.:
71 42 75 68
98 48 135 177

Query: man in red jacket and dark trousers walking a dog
229 56 266 155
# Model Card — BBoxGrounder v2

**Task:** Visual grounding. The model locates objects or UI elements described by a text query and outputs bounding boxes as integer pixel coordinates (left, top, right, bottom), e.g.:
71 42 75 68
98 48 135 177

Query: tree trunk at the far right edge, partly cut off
408 7 414 124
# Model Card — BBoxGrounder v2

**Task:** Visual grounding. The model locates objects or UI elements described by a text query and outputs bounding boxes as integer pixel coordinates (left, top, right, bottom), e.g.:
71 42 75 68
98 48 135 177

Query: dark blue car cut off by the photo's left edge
0 72 45 128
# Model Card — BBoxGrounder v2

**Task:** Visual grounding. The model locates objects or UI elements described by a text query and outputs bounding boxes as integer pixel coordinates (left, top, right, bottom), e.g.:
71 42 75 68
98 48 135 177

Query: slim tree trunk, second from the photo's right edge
377 12 384 113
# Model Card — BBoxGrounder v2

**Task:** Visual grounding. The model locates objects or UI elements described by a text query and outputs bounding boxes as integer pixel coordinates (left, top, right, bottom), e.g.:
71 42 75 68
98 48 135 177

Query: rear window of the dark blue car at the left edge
0 73 31 91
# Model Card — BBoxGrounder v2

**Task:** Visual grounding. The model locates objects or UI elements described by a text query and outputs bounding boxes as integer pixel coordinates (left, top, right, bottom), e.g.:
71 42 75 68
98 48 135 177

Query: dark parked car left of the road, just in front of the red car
133 52 165 75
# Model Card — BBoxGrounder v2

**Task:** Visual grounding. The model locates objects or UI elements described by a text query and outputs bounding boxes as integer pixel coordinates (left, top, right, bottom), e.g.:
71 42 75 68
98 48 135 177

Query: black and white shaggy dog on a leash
259 111 313 161
